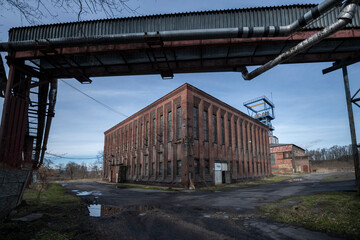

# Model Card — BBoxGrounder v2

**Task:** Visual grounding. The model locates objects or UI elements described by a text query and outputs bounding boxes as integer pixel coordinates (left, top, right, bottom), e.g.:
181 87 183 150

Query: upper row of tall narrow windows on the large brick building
106 106 266 156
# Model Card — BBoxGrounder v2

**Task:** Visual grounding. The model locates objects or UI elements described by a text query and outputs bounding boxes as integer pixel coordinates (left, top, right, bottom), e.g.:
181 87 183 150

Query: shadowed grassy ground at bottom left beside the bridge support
0 184 95 240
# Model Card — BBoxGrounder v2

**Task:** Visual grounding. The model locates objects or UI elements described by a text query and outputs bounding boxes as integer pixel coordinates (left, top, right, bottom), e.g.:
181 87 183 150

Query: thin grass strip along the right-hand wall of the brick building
199 175 300 191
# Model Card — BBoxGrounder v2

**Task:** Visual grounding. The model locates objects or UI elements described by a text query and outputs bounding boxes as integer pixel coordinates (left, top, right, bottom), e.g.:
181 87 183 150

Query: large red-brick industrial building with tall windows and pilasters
103 84 271 186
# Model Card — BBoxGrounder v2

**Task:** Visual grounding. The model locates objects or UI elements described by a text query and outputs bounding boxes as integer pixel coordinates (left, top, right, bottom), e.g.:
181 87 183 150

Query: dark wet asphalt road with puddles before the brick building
64 174 355 240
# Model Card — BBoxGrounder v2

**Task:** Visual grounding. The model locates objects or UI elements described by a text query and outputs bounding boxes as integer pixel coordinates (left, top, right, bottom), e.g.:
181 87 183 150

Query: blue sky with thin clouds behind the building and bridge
0 0 360 167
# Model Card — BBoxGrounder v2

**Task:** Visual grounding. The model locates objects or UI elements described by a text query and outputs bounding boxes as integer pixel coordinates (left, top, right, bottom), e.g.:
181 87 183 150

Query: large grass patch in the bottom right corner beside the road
260 192 360 238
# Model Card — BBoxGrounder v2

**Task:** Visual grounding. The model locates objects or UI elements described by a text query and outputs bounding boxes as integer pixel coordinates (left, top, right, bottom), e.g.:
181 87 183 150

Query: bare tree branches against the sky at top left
0 0 137 24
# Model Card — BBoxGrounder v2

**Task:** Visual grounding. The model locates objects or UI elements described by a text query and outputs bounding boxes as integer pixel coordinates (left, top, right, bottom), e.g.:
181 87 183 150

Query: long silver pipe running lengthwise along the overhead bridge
0 0 343 52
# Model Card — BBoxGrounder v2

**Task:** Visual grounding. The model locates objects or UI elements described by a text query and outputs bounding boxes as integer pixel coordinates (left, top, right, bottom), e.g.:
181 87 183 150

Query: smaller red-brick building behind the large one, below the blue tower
270 144 311 174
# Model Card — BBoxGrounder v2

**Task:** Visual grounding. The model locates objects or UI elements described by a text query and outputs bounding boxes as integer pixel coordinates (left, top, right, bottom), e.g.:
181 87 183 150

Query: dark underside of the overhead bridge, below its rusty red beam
48 52 360 78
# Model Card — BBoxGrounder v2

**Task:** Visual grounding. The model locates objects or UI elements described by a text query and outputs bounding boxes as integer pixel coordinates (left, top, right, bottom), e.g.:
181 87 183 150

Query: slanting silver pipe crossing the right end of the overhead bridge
238 0 359 80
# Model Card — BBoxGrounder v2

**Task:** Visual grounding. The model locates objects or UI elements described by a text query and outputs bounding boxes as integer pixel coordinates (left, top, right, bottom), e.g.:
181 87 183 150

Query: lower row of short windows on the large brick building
127 158 210 177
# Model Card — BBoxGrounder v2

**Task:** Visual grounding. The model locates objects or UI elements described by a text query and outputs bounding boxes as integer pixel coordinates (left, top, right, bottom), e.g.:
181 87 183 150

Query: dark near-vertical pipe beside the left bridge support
37 78 58 168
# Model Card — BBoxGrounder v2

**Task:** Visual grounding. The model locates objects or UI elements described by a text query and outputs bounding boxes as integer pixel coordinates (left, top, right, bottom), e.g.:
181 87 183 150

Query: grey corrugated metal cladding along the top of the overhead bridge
9 4 360 41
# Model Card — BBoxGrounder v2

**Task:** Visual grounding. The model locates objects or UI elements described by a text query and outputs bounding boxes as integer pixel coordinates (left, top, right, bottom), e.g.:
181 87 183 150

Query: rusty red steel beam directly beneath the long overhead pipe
9 29 360 59
